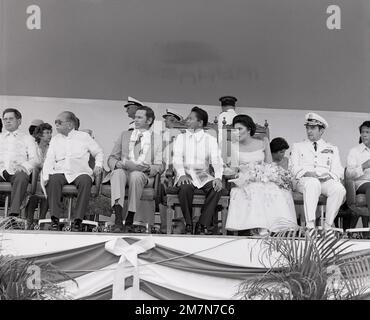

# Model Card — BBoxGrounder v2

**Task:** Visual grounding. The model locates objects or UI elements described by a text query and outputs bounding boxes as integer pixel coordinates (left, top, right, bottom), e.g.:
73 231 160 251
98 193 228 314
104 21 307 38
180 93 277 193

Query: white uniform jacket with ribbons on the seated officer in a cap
290 139 344 181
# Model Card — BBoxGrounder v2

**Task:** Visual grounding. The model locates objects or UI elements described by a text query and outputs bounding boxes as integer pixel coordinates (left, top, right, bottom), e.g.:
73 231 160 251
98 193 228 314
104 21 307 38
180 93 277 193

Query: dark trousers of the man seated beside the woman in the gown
179 181 221 227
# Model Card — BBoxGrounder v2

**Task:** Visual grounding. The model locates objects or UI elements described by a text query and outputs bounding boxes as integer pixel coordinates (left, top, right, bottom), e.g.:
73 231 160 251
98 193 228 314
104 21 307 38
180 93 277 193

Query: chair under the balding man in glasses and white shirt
35 169 103 232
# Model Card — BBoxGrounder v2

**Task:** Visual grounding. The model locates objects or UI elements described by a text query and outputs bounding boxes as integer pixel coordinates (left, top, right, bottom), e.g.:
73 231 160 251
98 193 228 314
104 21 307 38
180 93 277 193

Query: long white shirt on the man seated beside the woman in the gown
173 130 223 188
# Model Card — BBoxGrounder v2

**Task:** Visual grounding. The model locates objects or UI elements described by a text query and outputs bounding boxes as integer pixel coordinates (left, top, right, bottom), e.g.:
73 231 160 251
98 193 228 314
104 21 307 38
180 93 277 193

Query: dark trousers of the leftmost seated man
0 171 30 216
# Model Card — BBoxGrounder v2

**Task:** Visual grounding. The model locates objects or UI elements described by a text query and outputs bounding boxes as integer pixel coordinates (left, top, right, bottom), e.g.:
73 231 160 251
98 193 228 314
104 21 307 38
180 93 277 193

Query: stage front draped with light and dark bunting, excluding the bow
0 230 370 300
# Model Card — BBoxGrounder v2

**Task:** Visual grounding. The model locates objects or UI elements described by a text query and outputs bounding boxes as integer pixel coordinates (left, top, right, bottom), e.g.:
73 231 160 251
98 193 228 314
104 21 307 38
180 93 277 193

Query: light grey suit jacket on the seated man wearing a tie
103 130 164 183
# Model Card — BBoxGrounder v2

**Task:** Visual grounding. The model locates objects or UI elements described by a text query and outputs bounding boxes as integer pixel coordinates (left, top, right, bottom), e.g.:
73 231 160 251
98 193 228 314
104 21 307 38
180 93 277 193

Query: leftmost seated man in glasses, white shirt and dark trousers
0 109 39 221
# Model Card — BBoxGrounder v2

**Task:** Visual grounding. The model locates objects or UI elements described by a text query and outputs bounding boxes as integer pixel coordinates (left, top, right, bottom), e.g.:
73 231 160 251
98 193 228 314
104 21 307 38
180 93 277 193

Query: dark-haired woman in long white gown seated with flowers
226 115 297 235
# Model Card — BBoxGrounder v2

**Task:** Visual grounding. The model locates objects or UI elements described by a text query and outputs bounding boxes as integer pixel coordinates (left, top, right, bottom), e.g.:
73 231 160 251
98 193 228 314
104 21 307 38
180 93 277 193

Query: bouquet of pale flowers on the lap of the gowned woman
229 162 293 190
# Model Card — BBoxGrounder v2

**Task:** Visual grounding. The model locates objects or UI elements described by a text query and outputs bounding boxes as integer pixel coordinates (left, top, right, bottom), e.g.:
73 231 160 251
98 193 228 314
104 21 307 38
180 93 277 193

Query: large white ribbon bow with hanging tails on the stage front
105 236 155 300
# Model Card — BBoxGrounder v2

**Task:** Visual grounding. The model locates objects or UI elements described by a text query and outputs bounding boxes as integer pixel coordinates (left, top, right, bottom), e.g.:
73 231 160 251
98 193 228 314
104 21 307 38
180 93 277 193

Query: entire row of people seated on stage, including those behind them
0 97 370 235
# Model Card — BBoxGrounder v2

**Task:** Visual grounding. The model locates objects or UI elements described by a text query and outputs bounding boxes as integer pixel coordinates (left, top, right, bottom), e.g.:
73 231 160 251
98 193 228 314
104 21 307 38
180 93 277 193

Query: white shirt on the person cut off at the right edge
347 143 370 190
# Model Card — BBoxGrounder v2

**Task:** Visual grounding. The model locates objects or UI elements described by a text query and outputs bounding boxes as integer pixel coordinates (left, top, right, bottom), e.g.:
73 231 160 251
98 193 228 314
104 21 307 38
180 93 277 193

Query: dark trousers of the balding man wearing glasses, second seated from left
46 173 92 220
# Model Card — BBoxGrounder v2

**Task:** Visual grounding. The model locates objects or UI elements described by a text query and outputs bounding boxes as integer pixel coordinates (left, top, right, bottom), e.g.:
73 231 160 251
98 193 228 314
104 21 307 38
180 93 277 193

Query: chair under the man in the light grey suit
101 173 161 232
